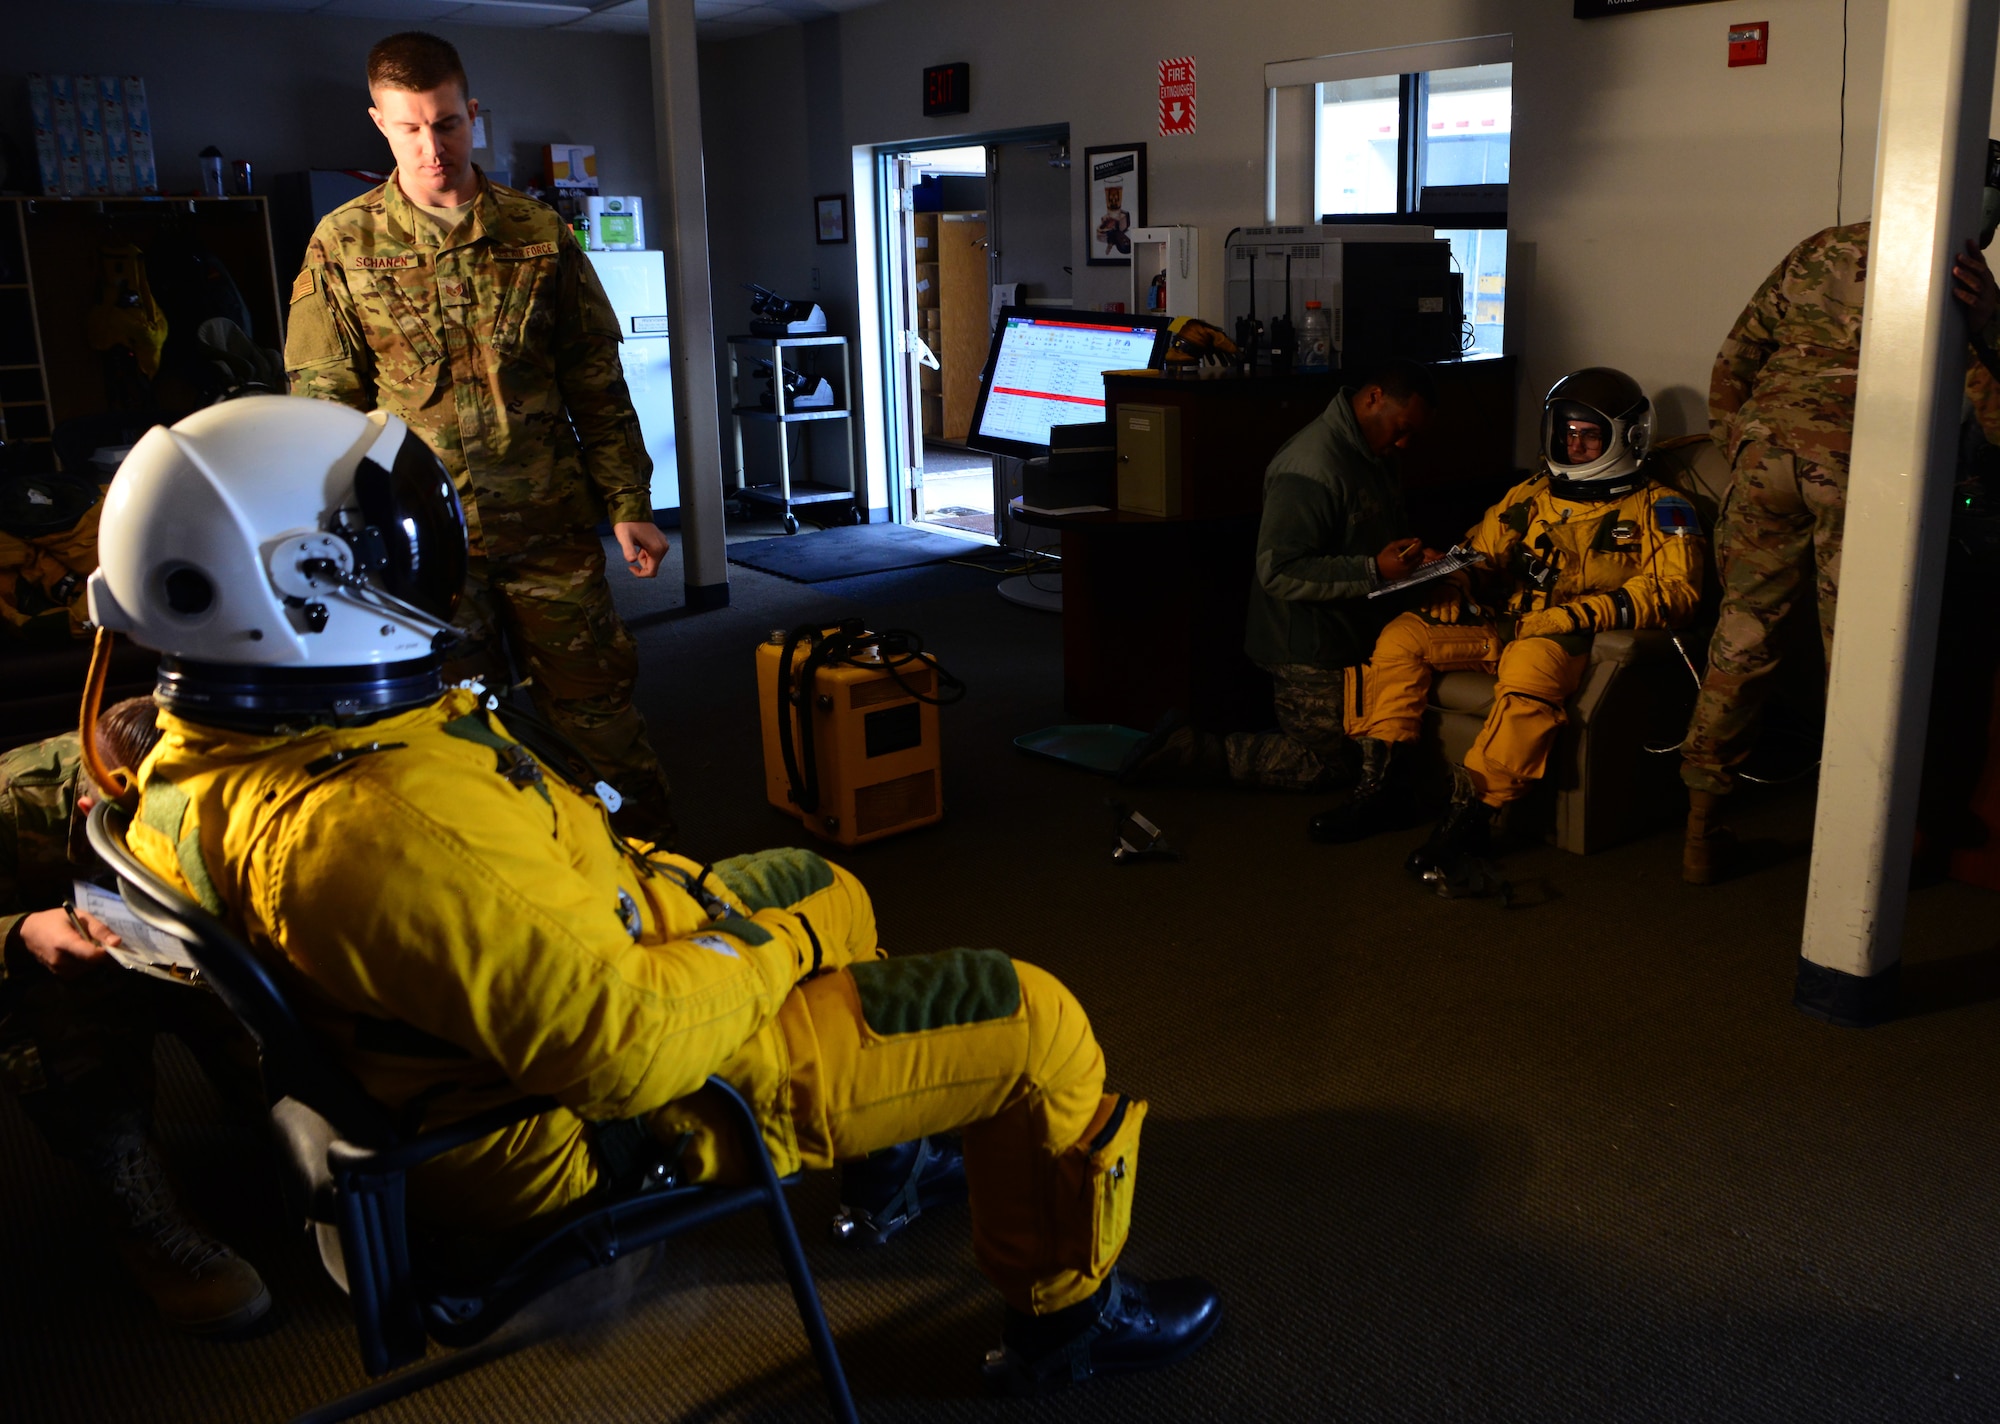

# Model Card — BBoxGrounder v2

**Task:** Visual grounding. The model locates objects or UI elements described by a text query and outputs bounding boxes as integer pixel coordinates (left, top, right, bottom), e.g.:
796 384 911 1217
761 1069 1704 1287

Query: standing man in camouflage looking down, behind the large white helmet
286 34 672 844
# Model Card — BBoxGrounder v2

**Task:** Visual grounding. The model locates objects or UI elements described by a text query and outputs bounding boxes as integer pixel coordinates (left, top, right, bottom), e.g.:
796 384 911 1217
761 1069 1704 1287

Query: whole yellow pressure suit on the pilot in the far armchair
1346 472 1708 806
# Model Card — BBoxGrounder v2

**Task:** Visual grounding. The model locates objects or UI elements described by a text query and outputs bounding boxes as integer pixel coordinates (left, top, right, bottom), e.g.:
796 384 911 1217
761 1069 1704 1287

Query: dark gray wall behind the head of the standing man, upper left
0 0 658 276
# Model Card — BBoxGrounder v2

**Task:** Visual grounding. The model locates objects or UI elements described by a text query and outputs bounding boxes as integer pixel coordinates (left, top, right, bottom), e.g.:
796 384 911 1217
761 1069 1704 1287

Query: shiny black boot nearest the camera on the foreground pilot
986 1270 1222 1394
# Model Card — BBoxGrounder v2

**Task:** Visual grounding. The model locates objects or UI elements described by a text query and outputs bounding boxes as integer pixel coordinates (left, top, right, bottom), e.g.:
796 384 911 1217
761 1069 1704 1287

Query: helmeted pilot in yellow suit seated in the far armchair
1312 366 1708 876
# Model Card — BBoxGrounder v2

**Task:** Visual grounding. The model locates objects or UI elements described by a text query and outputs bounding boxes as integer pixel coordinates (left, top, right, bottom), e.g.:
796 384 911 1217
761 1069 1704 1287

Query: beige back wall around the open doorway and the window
702 0 2000 458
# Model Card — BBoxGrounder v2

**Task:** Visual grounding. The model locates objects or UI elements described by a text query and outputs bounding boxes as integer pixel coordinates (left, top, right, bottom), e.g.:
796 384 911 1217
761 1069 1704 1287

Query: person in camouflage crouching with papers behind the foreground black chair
0 698 270 1332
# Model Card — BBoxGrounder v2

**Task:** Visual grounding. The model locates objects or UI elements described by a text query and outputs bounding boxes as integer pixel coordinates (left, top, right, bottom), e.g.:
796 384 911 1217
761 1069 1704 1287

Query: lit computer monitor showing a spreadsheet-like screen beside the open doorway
966 306 1168 460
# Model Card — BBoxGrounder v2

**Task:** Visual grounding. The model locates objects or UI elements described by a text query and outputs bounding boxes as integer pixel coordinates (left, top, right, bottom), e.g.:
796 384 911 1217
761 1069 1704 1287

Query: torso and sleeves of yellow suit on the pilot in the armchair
1466 470 1708 632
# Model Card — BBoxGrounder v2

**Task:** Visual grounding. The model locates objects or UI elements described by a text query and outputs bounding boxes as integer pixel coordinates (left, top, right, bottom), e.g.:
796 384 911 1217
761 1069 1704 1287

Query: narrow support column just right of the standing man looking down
648 0 730 610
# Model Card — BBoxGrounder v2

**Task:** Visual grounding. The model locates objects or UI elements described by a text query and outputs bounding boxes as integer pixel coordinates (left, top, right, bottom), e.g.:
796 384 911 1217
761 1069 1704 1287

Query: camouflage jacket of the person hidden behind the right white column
1708 222 2000 470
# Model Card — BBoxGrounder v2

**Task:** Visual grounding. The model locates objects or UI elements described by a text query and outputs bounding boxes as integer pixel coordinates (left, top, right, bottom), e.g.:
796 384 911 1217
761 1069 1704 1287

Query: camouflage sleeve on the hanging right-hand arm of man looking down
556 240 652 524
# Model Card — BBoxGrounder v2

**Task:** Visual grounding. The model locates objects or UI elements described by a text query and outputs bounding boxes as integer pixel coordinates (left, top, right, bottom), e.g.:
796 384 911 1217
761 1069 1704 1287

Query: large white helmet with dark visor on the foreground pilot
90 396 466 722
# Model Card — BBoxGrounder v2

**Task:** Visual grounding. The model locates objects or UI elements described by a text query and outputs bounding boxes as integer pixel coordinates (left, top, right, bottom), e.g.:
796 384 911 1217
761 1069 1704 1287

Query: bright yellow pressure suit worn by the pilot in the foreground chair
132 692 1146 1312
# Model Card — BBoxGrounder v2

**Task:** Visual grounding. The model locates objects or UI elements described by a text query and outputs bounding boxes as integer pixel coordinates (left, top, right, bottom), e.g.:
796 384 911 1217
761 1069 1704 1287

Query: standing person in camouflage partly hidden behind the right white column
1680 222 2000 884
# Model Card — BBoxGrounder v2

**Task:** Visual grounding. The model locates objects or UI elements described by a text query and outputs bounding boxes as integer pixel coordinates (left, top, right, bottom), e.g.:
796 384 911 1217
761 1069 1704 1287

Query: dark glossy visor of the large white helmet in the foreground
354 430 466 622
